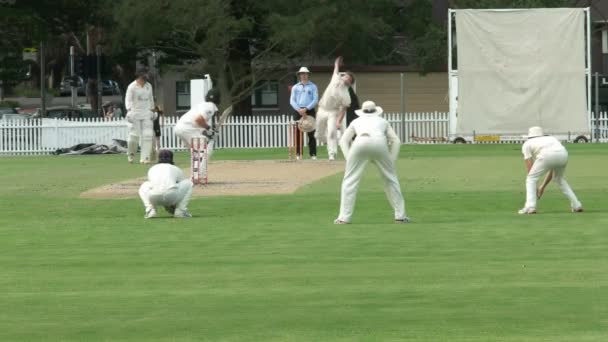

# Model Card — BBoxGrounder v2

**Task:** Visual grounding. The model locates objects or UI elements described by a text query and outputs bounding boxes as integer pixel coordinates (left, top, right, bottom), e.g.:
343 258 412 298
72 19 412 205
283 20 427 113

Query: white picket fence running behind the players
0 112 608 155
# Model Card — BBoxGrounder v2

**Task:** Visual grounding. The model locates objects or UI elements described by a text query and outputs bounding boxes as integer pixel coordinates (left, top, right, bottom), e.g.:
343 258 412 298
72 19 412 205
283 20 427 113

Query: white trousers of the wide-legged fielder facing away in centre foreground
338 135 406 222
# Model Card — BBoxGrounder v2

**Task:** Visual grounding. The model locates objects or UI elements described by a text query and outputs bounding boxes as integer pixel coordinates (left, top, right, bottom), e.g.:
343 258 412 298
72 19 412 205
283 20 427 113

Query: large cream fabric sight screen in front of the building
455 8 589 135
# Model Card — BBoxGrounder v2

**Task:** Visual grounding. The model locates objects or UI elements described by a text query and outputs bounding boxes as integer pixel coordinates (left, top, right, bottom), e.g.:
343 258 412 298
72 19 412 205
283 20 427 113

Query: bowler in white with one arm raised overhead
315 56 355 160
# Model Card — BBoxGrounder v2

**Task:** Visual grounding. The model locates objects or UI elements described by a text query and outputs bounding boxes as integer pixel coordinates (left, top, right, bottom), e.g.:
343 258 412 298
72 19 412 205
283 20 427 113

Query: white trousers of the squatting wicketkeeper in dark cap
139 179 192 211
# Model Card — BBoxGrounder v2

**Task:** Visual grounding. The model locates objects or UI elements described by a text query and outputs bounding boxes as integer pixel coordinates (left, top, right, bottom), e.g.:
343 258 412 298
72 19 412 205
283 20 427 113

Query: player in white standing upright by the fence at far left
125 70 158 164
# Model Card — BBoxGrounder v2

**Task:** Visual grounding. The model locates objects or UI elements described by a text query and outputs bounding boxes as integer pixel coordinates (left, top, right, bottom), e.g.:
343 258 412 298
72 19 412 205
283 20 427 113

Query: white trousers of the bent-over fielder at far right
524 151 582 208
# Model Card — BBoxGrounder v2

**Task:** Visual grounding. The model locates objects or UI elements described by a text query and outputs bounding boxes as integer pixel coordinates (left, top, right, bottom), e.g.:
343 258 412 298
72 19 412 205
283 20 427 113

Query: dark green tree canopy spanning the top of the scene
0 0 596 109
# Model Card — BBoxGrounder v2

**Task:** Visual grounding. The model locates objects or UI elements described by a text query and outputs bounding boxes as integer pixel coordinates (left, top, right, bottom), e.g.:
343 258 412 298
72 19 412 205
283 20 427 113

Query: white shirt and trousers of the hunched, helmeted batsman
173 102 218 158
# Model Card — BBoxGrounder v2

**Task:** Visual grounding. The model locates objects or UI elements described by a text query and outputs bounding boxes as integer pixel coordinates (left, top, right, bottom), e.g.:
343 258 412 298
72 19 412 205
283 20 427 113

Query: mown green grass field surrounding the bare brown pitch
0 144 608 342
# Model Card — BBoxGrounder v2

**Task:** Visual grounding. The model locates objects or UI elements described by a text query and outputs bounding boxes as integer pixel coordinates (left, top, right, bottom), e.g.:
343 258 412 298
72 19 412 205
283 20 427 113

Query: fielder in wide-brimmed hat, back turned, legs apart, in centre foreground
334 101 410 224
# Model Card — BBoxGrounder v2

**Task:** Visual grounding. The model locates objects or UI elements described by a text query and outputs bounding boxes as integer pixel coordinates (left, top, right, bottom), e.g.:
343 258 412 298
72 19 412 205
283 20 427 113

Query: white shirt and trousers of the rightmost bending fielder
522 136 582 209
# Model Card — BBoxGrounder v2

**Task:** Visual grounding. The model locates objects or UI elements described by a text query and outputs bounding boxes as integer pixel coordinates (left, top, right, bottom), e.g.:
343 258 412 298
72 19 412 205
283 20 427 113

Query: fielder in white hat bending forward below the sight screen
518 126 583 215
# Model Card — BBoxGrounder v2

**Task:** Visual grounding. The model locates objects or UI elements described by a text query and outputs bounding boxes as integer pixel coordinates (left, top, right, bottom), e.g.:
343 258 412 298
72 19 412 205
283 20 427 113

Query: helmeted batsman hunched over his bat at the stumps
173 88 220 160
